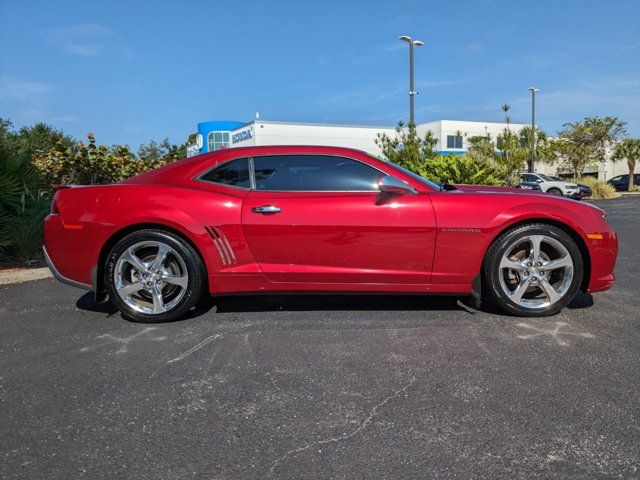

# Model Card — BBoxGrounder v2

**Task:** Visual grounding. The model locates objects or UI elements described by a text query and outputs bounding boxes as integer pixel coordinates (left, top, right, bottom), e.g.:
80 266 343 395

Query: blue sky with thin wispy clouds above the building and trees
0 0 640 148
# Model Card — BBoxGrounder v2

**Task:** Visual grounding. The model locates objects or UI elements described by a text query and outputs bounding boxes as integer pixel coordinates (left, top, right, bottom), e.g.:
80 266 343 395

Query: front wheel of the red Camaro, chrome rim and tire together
483 224 584 317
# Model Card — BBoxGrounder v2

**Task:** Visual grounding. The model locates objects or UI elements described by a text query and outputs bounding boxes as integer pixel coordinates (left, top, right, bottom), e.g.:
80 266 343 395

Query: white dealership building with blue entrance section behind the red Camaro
196 119 628 180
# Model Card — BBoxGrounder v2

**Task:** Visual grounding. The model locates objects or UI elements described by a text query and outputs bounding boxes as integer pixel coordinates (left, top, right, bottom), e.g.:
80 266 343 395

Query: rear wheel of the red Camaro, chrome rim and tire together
105 230 204 322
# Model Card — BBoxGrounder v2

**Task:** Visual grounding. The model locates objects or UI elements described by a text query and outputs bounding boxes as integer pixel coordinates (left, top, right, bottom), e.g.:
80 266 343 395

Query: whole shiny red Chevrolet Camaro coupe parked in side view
44 146 618 322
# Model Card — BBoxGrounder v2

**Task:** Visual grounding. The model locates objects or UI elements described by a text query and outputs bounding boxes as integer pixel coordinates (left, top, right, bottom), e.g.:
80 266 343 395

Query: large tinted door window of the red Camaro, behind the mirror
253 155 385 192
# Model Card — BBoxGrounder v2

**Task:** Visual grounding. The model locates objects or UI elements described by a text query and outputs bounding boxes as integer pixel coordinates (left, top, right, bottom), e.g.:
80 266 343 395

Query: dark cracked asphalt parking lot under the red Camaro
0 196 640 479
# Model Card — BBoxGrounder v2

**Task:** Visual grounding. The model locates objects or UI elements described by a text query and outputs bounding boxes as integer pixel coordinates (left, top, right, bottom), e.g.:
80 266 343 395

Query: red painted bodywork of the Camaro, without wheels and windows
45 146 618 294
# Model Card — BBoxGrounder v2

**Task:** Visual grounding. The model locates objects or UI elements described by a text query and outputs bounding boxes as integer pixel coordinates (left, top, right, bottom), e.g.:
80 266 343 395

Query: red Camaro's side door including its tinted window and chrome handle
242 154 435 284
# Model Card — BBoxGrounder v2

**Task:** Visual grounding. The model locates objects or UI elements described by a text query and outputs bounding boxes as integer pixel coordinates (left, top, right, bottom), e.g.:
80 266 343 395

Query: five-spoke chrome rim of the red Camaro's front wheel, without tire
499 235 574 309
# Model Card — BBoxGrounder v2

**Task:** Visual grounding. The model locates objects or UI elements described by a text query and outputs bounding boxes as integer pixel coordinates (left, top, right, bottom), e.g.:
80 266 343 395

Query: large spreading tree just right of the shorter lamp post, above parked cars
551 117 626 180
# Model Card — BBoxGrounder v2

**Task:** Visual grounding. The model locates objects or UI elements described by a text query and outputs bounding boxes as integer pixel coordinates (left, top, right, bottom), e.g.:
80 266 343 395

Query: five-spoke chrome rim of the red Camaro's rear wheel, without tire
113 241 189 314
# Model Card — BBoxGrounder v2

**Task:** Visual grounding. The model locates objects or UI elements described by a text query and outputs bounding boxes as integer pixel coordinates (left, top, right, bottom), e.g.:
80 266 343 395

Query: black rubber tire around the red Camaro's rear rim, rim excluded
104 229 206 323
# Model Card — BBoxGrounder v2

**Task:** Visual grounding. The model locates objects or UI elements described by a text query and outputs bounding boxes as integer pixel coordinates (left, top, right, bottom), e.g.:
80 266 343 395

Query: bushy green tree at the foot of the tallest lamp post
376 122 438 174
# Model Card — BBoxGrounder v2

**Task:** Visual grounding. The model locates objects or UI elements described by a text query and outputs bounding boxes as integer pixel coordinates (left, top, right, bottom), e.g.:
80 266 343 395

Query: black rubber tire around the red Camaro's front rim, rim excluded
482 223 584 317
